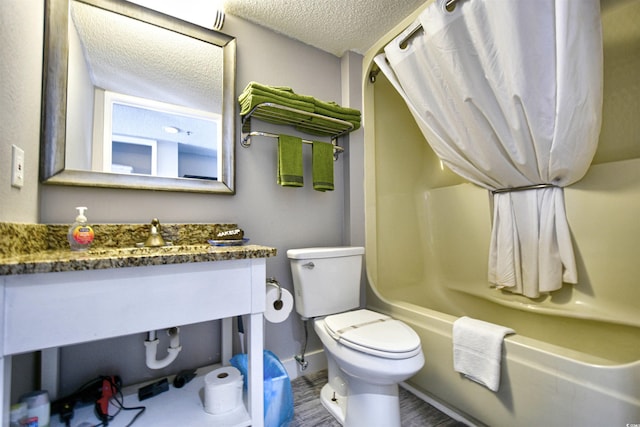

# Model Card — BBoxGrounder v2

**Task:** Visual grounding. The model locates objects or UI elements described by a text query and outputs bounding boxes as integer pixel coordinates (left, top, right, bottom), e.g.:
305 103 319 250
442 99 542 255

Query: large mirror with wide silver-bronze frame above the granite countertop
40 0 236 194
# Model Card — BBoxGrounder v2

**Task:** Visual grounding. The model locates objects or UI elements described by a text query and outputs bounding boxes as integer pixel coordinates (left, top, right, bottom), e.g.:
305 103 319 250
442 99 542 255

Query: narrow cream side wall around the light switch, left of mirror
0 0 44 223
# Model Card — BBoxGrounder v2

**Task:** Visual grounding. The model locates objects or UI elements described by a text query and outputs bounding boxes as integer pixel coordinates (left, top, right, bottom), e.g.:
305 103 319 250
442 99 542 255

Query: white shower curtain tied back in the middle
375 0 602 298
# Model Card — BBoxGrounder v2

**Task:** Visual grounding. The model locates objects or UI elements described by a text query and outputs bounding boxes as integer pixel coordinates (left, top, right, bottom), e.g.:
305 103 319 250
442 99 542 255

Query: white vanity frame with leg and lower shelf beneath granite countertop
0 260 270 427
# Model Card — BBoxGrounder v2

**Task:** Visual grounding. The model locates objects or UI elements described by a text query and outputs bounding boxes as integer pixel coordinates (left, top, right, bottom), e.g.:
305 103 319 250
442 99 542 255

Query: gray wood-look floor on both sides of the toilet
291 370 465 427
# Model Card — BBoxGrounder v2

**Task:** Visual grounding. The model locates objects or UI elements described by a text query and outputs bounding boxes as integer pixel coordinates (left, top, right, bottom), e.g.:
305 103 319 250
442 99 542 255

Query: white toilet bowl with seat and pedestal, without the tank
314 310 424 427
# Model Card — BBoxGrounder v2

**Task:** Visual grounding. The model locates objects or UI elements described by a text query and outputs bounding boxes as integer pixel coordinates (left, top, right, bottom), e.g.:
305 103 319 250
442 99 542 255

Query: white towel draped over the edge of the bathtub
453 316 515 391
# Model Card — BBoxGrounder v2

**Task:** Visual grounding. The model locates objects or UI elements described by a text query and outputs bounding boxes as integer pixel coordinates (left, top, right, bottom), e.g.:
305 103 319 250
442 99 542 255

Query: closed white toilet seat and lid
324 310 421 359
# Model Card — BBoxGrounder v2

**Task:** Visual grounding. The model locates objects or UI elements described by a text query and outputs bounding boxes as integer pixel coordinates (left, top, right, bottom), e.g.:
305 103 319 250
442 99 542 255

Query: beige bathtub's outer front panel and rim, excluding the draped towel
364 301 640 427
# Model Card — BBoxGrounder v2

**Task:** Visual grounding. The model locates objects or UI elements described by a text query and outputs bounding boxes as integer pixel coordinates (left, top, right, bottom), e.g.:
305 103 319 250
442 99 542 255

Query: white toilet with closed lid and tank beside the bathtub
287 247 424 427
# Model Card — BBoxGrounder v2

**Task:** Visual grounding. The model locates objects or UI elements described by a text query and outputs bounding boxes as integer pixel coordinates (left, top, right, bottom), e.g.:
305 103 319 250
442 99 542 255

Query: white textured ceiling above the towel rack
223 0 425 56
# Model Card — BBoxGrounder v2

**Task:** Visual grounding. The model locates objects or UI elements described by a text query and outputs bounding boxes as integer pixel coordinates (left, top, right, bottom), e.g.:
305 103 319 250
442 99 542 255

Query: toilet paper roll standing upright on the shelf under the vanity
204 366 243 415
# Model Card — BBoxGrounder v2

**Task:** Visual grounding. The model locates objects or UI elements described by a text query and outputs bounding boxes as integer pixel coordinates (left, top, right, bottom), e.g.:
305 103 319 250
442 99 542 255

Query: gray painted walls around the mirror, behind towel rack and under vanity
0 0 364 396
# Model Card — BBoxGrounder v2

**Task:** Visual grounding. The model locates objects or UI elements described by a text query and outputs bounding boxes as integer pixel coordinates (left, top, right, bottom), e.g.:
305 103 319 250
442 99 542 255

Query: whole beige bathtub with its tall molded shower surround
363 1 640 427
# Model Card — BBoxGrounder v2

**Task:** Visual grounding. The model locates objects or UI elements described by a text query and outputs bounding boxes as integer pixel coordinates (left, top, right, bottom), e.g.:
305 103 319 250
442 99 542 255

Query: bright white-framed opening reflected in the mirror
90 92 221 180
